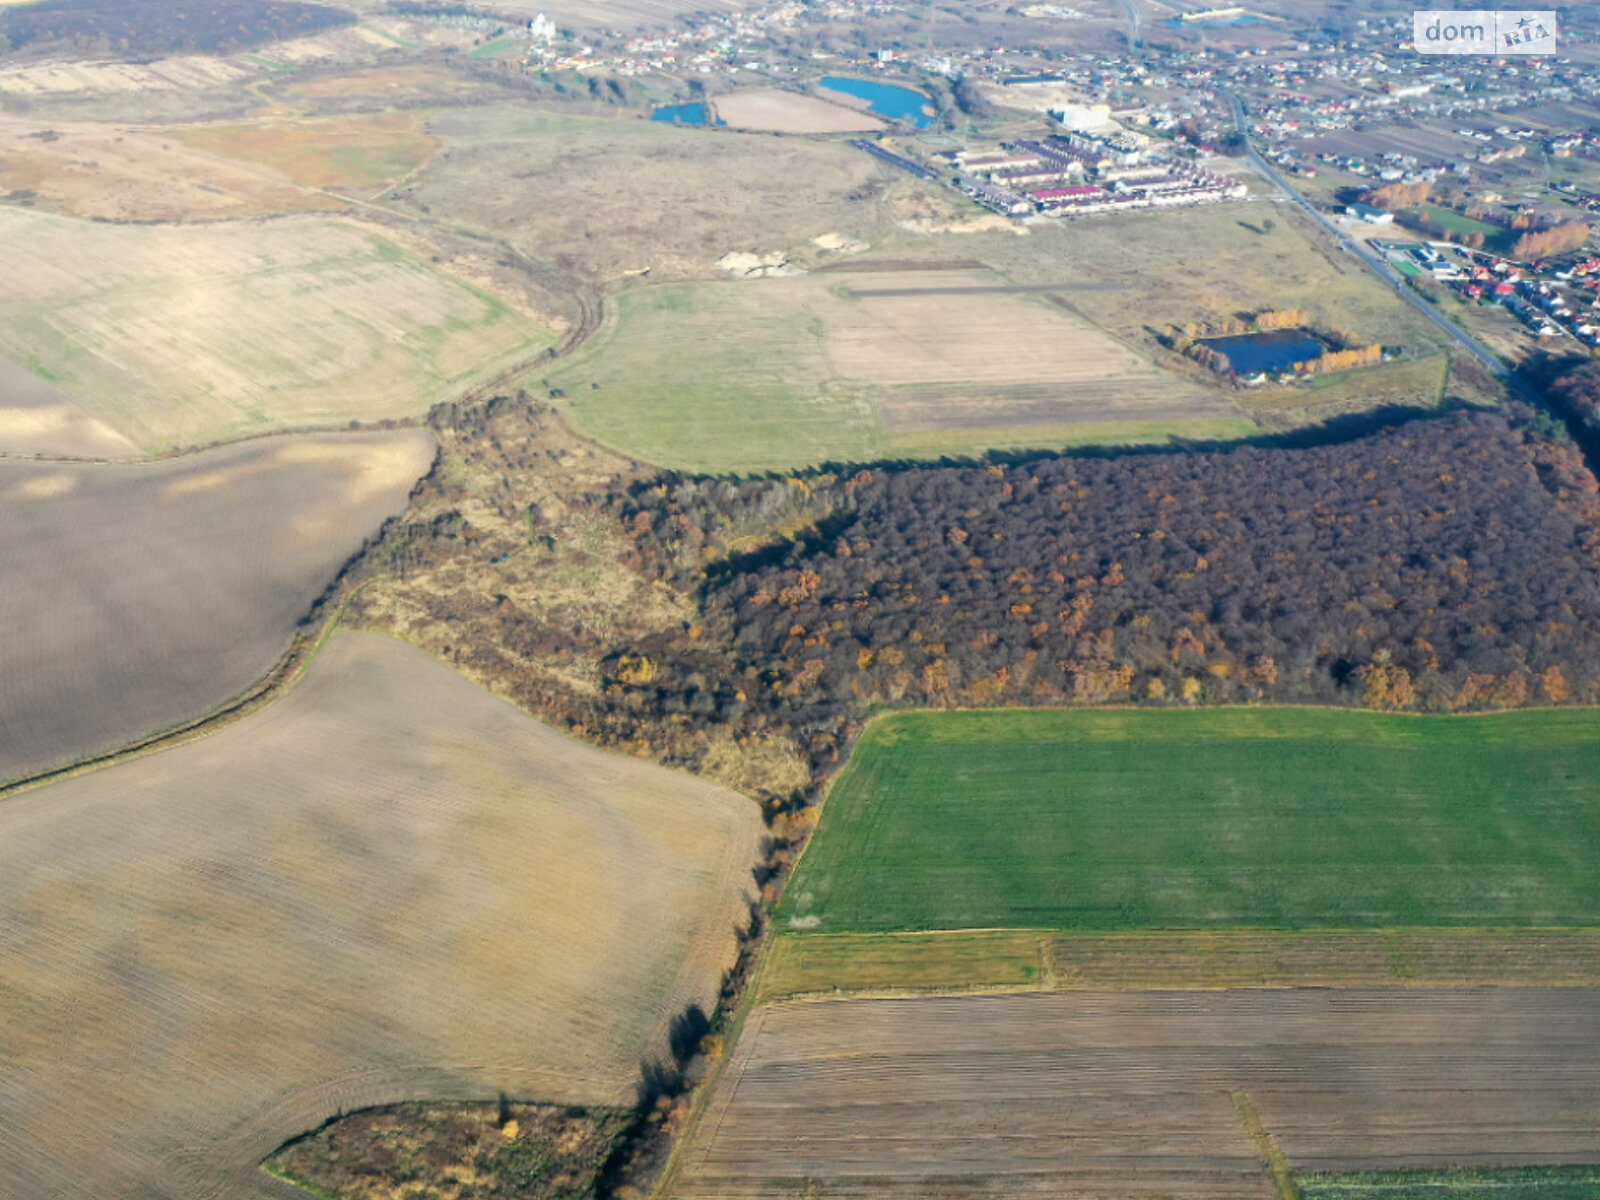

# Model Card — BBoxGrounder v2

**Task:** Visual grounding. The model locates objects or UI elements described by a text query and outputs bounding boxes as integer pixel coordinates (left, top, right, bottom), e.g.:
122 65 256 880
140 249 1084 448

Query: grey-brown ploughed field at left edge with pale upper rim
0 432 434 782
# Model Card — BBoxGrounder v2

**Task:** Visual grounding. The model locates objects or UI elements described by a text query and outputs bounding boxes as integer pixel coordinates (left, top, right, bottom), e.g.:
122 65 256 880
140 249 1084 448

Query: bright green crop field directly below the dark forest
779 709 1600 931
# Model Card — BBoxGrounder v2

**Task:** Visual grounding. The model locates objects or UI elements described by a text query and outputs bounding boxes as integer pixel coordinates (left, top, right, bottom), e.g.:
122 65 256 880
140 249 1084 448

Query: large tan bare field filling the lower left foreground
0 632 762 1200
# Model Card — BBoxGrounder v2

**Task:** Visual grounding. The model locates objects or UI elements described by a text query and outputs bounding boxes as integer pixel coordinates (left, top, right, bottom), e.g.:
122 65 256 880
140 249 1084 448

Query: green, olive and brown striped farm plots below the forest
700 709 1600 1200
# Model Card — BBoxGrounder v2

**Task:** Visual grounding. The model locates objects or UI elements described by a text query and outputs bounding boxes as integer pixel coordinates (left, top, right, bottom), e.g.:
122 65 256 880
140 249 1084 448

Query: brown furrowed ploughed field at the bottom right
672 987 1600 1200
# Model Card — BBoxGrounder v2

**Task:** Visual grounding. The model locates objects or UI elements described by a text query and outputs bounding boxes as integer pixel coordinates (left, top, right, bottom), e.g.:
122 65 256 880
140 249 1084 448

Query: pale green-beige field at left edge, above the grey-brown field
0 208 552 450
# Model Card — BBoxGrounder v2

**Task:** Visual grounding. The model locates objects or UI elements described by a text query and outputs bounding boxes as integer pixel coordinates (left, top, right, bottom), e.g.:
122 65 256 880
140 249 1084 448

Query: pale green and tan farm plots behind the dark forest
546 272 1253 470
